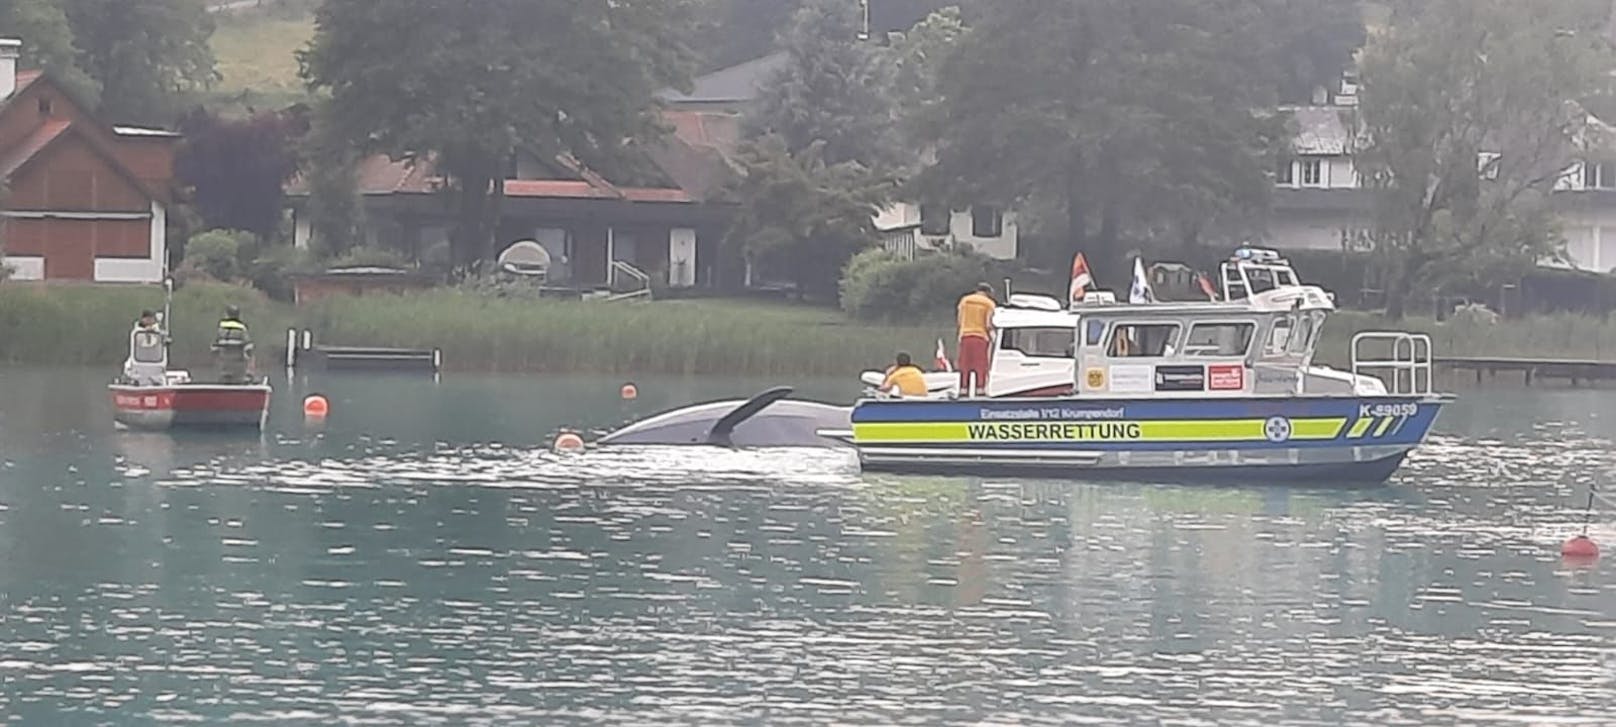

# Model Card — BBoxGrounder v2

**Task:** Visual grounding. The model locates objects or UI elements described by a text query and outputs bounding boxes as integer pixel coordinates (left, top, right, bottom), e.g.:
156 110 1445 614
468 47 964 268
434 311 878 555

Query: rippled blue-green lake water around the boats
0 368 1616 725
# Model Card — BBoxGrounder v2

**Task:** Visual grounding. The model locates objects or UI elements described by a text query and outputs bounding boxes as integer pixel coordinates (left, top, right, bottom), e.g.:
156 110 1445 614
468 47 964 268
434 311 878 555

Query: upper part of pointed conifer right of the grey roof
748 0 903 170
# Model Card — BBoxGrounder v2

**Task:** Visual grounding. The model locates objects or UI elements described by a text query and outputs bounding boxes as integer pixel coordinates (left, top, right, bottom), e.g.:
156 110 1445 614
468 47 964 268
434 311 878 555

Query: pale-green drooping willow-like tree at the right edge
1356 0 1616 317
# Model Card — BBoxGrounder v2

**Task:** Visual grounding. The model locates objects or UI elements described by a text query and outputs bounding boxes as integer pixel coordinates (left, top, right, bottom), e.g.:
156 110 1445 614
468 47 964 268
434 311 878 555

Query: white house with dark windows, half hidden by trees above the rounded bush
874 202 1020 260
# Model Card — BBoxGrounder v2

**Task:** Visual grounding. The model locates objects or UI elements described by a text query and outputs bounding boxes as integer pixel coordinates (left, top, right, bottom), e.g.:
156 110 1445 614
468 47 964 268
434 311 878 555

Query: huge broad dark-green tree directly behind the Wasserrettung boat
918 0 1283 281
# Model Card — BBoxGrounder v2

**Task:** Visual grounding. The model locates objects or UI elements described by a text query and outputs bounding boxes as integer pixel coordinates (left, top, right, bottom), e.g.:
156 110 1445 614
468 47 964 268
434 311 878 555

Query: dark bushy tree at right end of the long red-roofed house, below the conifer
727 134 892 297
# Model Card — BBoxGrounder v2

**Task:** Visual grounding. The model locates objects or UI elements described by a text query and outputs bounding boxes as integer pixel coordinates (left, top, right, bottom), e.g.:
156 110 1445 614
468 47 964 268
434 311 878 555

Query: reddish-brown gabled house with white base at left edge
0 39 179 283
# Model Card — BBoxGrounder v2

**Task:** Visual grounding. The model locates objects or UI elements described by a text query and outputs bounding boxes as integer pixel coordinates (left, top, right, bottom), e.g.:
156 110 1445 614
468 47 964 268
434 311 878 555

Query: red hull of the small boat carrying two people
108 385 270 430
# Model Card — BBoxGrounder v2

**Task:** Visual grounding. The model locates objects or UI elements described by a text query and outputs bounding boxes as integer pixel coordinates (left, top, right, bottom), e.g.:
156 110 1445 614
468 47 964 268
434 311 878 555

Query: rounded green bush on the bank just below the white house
842 250 1000 320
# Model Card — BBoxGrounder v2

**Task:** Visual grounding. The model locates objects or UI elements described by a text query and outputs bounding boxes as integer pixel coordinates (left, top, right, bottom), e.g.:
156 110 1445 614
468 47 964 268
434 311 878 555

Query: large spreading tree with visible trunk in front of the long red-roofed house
301 0 693 268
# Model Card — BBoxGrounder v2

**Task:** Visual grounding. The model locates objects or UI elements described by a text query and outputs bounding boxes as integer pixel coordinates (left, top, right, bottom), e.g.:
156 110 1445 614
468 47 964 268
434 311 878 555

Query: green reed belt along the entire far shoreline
9 283 1616 376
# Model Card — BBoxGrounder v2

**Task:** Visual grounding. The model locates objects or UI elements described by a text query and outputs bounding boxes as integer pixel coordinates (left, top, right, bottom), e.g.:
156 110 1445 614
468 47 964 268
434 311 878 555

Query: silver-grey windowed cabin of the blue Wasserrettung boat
1075 286 1353 397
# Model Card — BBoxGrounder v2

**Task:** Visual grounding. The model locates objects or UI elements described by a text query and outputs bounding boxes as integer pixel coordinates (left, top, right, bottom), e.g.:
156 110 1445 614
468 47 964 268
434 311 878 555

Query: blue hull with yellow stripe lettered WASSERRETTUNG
850 396 1450 483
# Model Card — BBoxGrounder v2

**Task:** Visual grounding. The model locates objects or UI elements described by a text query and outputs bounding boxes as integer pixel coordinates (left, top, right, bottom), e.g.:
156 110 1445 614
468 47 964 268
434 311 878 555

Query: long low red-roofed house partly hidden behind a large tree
286 129 734 291
